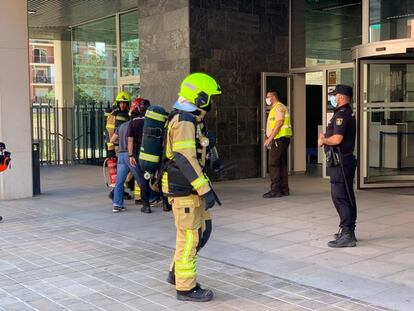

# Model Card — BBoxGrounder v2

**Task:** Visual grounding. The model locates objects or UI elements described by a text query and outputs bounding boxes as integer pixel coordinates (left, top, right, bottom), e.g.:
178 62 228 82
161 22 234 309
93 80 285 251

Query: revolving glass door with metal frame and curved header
354 40 414 188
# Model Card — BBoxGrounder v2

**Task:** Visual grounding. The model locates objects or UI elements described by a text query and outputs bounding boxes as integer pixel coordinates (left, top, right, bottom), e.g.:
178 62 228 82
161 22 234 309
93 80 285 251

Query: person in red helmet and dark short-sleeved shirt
127 98 151 213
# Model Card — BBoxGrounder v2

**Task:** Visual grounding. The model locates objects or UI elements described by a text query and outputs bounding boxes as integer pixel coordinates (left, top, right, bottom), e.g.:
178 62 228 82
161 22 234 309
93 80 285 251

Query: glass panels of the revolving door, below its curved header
363 62 414 181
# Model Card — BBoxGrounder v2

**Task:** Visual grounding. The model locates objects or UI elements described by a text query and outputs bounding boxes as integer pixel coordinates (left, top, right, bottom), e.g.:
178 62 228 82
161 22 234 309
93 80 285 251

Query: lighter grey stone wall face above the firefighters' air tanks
138 0 190 110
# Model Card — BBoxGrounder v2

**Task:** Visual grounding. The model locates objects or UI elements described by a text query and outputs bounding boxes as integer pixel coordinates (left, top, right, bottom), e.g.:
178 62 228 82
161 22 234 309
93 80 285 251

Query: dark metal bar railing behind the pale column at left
31 99 111 166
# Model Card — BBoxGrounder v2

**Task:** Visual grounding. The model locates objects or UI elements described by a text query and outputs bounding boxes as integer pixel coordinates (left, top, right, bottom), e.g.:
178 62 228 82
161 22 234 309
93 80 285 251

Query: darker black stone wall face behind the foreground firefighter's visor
189 0 289 179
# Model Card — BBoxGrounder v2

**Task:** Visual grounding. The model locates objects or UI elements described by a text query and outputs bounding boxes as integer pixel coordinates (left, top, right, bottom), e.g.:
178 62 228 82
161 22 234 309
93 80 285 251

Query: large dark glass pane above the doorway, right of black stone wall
291 0 362 68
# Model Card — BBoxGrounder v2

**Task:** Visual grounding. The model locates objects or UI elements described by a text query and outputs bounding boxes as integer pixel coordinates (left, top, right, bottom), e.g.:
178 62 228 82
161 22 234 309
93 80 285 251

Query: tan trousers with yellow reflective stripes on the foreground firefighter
169 195 211 291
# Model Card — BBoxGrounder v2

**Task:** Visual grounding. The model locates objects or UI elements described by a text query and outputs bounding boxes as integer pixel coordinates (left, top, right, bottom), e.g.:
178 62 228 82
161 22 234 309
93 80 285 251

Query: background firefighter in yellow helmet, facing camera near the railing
105 91 131 200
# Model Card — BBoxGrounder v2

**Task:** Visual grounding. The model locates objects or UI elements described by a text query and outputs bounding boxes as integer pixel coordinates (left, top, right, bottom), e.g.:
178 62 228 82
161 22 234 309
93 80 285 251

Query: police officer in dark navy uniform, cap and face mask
318 84 357 248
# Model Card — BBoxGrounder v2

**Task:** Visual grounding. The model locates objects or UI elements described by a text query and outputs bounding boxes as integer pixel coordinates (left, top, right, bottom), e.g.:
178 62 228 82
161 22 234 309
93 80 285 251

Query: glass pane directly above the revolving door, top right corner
369 0 414 42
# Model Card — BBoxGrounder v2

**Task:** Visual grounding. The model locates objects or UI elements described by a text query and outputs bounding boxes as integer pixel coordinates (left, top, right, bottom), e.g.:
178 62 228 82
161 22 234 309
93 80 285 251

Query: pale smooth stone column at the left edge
0 0 33 200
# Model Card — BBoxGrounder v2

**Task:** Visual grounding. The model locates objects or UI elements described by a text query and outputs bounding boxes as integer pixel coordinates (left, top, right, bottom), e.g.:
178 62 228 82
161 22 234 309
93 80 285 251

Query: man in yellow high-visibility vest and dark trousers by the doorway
263 91 292 199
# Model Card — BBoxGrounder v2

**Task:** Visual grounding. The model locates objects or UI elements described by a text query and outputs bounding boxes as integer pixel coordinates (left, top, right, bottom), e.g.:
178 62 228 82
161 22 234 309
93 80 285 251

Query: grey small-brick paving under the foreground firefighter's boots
0 202 383 311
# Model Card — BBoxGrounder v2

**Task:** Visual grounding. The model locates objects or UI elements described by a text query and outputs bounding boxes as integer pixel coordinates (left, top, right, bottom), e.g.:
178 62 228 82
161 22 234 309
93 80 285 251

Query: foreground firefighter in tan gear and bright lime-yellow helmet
162 73 221 301
